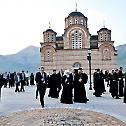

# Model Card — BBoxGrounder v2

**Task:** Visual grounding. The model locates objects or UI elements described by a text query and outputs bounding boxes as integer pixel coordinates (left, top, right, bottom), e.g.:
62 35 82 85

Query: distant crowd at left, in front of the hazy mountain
0 71 35 98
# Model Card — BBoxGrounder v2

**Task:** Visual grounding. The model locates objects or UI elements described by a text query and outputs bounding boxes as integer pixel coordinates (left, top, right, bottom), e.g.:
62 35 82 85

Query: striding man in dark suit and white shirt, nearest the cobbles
35 67 47 107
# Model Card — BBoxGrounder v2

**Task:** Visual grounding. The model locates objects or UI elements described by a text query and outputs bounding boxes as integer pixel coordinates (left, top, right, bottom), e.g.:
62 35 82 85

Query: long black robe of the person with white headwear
61 74 73 104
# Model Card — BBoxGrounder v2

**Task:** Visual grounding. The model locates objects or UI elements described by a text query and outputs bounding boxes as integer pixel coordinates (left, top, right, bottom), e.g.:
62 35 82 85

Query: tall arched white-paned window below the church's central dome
71 30 82 49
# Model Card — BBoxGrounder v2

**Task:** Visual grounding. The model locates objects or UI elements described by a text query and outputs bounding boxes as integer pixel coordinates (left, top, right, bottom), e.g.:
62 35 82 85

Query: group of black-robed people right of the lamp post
93 67 126 99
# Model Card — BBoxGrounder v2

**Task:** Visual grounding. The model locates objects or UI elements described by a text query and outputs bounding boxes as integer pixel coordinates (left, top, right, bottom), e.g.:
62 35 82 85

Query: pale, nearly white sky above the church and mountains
0 0 126 55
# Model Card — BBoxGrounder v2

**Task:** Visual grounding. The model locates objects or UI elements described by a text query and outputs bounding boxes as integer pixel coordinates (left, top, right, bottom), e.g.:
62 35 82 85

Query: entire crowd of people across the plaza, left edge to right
0 67 126 107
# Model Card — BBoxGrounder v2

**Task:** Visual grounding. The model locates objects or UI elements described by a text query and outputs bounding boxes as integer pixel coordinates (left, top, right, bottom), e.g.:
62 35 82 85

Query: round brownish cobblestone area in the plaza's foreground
0 108 126 126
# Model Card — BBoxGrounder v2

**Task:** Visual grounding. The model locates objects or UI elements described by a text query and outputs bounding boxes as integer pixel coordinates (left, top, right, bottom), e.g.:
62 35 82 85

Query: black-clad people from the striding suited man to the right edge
36 67 126 107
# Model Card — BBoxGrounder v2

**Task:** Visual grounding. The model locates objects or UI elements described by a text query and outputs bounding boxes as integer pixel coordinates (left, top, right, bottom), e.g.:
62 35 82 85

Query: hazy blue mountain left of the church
0 46 40 73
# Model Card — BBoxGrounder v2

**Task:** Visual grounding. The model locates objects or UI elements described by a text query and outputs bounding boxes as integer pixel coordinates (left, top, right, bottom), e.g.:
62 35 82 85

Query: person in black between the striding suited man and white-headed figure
48 70 61 98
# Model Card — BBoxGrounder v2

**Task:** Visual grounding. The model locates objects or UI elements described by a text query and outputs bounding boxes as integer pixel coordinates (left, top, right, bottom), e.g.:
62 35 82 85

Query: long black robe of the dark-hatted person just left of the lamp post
73 73 88 103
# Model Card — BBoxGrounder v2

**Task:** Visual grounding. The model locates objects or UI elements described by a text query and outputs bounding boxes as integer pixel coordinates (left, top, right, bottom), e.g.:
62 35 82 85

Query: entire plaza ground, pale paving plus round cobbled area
0 84 126 126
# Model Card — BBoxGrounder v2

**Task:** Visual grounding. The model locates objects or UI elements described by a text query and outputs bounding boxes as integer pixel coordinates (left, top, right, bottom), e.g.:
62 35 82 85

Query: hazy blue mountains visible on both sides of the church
0 44 126 73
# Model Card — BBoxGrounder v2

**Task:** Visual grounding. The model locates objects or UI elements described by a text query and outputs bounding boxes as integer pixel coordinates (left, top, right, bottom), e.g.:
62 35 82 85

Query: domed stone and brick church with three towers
40 10 117 73
